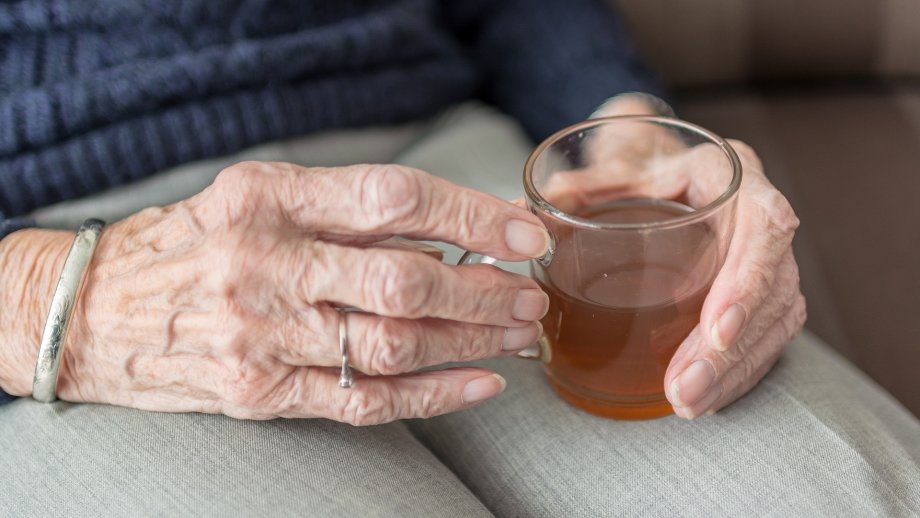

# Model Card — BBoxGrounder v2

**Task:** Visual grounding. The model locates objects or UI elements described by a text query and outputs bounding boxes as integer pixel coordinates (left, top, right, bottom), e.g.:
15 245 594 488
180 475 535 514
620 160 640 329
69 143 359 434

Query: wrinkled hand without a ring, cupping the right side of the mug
592 96 806 419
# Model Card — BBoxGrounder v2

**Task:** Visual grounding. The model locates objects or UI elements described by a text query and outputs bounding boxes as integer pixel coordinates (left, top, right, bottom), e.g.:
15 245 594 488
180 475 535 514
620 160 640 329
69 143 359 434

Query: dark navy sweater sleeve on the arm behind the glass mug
444 0 665 140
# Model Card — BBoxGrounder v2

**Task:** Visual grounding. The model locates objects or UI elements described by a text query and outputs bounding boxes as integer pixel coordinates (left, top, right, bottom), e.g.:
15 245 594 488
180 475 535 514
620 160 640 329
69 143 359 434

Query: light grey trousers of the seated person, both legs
14 101 920 516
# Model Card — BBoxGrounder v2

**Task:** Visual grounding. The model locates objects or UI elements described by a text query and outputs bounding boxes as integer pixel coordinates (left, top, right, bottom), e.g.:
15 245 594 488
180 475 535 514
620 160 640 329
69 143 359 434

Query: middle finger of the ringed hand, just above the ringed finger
288 242 549 327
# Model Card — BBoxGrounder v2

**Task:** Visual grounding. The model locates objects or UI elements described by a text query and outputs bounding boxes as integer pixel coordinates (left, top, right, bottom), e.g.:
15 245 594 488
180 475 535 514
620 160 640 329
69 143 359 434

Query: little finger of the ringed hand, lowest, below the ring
284 367 505 426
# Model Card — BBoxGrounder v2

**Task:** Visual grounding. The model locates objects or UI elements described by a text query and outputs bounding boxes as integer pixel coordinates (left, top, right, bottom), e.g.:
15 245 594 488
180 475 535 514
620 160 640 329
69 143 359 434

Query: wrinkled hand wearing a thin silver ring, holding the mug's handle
0 162 548 425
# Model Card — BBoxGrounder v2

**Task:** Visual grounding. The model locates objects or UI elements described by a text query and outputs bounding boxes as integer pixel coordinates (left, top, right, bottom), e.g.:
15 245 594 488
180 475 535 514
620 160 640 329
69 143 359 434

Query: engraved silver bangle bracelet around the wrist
32 219 105 403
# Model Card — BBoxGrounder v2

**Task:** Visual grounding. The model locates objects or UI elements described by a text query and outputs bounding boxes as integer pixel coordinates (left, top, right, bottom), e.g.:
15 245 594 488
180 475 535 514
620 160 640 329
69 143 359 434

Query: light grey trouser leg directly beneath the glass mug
409 336 920 516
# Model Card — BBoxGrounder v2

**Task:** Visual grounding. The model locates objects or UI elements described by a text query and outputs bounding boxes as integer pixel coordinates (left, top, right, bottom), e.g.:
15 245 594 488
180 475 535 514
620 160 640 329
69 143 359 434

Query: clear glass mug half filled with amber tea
460 116 741 419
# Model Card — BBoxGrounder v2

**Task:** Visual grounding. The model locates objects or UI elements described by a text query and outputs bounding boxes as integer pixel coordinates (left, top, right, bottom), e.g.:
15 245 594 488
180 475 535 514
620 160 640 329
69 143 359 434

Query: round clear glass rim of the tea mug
524 119 742 230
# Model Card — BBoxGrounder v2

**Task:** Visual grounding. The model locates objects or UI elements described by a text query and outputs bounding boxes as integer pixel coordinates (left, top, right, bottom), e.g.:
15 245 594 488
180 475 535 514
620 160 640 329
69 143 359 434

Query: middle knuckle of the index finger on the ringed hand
358 165 424 232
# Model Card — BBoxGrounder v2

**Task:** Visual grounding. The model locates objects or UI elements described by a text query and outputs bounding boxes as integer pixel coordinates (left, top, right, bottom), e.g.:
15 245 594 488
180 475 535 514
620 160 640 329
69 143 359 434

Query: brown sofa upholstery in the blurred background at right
617 0 920 415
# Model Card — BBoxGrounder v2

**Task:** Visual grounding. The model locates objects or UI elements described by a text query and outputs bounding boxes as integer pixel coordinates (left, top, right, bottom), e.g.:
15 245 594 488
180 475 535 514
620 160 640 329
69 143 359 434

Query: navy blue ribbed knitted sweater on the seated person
0 0 660 406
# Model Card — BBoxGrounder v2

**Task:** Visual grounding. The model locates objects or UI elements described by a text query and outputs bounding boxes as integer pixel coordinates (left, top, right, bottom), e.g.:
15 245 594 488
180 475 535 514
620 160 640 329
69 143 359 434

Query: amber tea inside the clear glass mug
534 199 717 419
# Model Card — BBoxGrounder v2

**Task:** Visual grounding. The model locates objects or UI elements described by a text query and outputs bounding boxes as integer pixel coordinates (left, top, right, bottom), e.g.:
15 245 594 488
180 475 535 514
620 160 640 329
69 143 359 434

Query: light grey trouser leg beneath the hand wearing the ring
0 399 491 517
